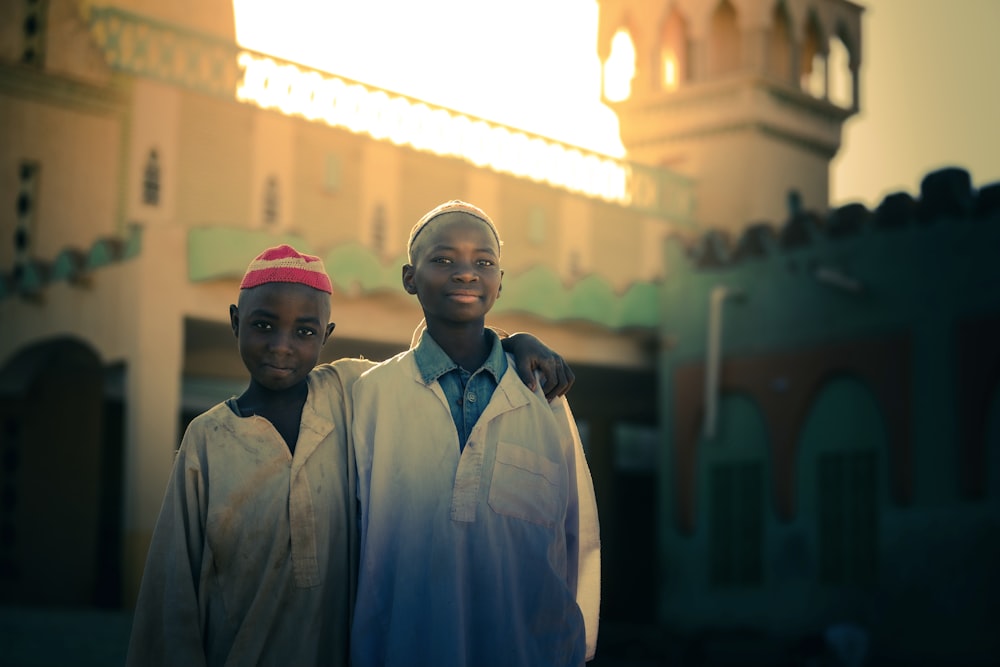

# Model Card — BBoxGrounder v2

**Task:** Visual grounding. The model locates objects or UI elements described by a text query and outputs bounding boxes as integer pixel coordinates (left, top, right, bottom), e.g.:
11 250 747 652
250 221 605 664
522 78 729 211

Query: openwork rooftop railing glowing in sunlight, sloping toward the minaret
90 7 694 225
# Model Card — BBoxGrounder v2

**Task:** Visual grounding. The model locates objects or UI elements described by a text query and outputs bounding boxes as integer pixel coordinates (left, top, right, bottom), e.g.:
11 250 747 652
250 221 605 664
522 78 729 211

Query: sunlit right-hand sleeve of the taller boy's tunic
550 397 601 660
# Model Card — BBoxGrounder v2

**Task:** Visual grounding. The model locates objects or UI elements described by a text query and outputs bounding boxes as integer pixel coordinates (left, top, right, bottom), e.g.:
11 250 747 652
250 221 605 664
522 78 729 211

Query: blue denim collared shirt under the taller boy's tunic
413 329 507 450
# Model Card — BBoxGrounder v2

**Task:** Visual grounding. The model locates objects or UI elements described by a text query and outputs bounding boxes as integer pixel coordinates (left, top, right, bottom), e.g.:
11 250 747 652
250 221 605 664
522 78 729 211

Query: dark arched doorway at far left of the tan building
0 339 121 606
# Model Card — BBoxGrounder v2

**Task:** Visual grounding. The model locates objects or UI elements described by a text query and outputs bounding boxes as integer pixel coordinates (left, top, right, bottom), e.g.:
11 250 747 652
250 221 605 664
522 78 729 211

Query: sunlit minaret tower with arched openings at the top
598 0 863 233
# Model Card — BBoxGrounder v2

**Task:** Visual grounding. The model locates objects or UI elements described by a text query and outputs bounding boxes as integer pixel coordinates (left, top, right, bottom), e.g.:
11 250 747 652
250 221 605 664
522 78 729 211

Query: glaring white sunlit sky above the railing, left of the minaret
233 0 625 157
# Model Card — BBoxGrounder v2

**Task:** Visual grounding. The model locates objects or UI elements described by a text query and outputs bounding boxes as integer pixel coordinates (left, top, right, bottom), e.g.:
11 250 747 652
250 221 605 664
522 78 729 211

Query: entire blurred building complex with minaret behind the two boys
0 0 1000 665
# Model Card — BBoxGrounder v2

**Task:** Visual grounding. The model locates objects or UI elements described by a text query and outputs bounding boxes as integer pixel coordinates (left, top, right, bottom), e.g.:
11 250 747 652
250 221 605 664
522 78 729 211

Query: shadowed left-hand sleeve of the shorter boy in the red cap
126 435 206 667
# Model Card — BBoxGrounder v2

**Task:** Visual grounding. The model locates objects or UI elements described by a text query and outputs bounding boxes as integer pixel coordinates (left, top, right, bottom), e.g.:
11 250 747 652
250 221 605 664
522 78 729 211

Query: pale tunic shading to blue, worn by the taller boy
351 351 600 667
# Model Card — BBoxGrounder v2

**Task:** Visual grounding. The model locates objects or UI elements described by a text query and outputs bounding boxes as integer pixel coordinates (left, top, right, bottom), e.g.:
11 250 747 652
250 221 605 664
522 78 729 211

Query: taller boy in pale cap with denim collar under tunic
351 201 600 667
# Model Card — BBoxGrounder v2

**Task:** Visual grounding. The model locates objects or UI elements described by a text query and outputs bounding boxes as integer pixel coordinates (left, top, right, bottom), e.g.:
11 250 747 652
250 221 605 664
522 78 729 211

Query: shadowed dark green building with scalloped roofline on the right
659 168 1000 664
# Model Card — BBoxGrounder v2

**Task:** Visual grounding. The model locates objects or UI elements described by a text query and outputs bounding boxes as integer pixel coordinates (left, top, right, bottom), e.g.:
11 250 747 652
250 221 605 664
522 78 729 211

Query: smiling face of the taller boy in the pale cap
403 211 503 322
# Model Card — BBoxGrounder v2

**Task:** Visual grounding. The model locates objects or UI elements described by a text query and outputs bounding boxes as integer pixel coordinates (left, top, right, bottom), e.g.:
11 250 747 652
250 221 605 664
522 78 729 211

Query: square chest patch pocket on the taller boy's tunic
489 441 562 527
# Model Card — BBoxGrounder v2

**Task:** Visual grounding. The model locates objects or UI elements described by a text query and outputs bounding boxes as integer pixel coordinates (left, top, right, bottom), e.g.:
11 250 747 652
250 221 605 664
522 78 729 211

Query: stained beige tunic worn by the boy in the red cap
128 360 373 667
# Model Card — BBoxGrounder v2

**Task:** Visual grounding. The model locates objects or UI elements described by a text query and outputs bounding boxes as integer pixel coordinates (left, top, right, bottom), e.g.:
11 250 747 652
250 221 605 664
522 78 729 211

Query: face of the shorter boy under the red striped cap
229 283 334 391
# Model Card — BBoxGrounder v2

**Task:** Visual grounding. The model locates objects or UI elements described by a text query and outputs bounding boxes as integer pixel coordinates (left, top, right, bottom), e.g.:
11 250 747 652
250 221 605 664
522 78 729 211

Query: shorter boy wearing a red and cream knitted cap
128 246 576 666
